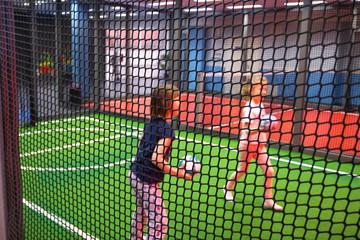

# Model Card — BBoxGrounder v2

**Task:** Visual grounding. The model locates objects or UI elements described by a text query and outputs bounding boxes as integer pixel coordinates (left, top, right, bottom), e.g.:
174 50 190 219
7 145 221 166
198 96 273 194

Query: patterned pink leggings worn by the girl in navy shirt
129 171 168 240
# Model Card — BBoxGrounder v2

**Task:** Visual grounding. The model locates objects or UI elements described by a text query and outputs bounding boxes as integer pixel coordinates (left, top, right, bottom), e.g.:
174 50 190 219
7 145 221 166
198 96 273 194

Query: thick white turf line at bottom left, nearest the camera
23 198 99 240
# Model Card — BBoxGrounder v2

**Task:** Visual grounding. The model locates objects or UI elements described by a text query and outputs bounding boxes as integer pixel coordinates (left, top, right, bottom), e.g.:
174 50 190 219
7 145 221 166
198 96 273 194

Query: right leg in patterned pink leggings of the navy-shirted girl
148 184 168 239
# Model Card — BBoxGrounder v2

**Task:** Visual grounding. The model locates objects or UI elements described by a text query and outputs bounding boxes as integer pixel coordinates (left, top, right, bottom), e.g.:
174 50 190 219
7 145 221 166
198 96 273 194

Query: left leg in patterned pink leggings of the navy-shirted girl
129 171 149 240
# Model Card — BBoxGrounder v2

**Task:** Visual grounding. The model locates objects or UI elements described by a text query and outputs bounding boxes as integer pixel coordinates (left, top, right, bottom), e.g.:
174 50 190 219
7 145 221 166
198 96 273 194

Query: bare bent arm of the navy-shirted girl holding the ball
151 138 193 179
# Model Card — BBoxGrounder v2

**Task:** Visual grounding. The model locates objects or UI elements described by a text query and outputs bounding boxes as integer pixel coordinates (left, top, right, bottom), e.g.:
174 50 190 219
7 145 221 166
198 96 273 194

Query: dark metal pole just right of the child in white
292 0 311 152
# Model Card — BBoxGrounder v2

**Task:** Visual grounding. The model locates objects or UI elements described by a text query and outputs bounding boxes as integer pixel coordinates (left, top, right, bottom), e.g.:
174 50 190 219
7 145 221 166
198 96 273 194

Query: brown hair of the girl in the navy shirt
151 84 180 118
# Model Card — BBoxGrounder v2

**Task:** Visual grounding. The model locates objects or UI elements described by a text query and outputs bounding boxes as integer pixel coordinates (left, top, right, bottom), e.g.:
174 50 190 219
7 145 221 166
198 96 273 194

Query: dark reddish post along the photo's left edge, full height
0 0 25 239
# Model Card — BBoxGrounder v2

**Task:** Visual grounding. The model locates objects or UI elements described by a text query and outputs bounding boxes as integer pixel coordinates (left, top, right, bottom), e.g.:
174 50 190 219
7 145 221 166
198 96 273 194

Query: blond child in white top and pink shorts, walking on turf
223 76 283 211
